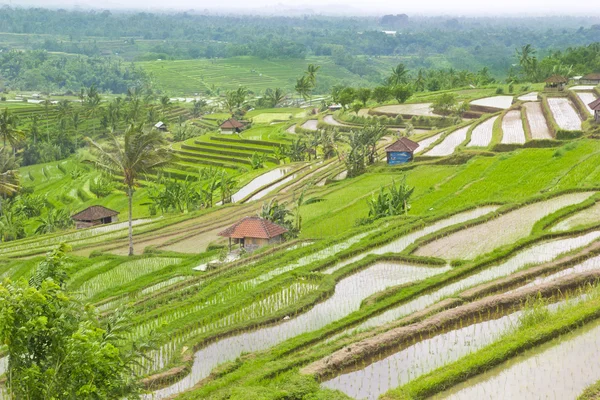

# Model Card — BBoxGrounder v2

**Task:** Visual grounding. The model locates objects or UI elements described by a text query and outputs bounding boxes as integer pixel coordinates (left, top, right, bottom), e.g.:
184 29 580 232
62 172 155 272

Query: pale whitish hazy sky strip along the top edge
0 0 600 16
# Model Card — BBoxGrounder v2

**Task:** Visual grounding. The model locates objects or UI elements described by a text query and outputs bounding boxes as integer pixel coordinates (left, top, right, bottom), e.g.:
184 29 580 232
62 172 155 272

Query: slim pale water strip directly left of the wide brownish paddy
323 206 498 274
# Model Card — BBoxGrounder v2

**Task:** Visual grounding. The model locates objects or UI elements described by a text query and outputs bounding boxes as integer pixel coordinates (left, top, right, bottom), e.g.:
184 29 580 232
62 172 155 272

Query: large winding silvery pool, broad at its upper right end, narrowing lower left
146 263 449 399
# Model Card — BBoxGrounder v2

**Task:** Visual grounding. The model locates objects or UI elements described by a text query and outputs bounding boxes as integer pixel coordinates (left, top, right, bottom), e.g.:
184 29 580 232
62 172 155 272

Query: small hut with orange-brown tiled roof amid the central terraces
219 217 288 251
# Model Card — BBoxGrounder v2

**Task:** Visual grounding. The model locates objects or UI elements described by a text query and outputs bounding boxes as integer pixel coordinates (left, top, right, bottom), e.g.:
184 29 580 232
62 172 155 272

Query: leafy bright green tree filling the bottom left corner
0 245 150 399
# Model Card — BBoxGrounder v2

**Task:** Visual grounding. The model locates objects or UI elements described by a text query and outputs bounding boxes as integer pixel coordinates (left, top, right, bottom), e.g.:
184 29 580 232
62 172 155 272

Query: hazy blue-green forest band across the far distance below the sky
0 7 600 77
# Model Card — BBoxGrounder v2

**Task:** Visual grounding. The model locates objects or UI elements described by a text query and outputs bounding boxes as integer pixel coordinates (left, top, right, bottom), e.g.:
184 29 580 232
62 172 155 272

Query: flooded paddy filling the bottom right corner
435 321 600 400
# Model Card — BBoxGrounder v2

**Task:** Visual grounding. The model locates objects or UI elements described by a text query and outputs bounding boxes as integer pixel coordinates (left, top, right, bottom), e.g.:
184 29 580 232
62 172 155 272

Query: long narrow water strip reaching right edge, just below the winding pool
344 231 600 331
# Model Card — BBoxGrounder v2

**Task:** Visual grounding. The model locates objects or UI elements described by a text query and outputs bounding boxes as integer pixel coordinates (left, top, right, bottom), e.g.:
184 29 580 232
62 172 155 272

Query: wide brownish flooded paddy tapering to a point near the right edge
415 192 593 260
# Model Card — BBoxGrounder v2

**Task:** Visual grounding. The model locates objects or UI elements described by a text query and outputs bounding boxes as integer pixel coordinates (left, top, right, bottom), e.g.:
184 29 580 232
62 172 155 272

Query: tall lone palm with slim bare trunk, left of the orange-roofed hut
86 124 173 256
